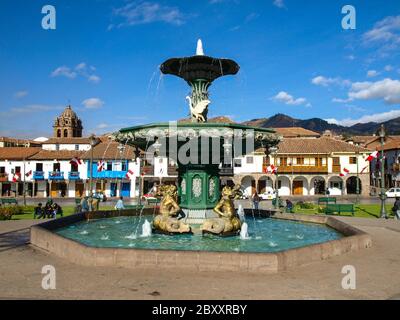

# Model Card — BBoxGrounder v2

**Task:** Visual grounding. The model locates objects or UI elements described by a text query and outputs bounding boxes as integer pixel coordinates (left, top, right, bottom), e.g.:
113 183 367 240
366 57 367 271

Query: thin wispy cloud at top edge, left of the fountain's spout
109 1 187 29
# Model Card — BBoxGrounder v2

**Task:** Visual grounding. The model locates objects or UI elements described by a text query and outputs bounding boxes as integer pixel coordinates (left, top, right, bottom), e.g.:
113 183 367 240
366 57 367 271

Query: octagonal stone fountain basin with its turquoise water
31 210 372 273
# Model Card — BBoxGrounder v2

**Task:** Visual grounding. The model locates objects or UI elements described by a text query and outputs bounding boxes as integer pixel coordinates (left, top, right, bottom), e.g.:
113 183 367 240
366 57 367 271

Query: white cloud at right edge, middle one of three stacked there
348 78 400 104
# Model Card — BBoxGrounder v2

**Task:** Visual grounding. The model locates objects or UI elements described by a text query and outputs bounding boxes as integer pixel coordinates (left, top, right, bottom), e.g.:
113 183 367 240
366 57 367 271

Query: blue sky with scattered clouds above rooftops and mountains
0 0 400 137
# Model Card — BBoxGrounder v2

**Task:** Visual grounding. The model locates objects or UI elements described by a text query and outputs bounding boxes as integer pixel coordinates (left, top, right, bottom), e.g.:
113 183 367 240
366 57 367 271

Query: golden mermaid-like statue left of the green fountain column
153 185 191 233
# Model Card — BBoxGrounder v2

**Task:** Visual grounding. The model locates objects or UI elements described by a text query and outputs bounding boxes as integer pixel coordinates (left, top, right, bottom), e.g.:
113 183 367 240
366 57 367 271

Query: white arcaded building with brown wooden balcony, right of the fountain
233 137 370 196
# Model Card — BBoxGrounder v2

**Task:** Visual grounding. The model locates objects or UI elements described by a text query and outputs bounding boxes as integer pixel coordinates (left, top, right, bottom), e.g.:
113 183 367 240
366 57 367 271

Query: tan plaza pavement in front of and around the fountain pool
0 217 400 300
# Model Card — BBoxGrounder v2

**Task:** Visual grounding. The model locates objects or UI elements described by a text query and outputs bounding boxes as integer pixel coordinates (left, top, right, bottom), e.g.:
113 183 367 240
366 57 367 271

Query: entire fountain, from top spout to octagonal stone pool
31 40 371 273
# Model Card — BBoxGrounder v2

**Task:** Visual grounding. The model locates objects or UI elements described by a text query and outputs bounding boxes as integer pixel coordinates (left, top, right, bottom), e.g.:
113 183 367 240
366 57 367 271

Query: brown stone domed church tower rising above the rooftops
53 105 83 138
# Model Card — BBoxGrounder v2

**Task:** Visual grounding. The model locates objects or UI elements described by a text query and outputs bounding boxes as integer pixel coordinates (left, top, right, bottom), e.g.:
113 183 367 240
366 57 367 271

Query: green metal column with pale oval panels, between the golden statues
178 164 220 210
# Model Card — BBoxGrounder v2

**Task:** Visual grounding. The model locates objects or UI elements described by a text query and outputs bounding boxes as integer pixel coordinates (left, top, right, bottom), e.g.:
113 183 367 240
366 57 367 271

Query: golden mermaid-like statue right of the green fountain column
201 185 241 235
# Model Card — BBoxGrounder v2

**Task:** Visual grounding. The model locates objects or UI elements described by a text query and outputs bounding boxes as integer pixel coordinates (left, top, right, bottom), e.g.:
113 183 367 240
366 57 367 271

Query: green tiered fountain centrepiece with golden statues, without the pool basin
115 40 279 235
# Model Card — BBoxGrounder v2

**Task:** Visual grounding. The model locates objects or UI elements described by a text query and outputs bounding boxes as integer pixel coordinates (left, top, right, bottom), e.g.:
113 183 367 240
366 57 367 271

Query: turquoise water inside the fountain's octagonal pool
56 216 342 252
